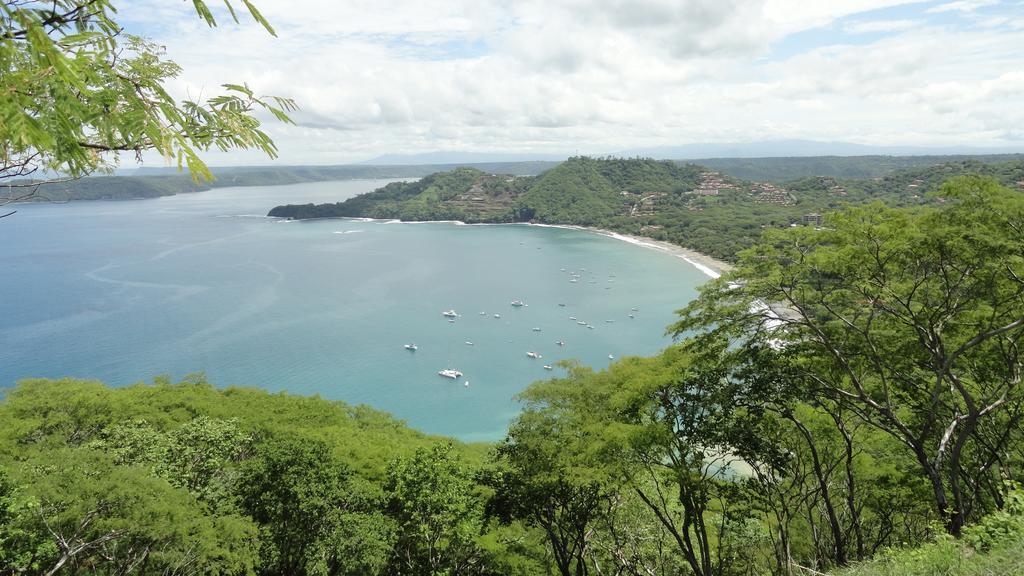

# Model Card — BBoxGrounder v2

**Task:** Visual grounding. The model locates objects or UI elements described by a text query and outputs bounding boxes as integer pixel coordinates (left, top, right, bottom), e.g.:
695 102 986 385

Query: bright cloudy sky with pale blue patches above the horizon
118 0 1024 165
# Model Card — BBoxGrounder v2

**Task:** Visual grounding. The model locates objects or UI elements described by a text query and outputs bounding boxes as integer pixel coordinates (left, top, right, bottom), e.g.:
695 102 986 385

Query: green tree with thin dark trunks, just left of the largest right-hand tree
523 343 766 576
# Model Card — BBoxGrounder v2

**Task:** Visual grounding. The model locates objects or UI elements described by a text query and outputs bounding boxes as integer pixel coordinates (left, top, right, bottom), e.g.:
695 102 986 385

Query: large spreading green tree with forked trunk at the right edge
674 176 1024 534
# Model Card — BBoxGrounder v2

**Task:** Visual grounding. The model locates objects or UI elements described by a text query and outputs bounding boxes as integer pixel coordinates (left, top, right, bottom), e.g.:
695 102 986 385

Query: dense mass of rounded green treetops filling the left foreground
0 379 516 575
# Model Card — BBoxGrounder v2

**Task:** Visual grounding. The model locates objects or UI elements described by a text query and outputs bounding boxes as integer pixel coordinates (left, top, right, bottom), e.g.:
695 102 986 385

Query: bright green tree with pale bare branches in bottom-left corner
5 448 256 576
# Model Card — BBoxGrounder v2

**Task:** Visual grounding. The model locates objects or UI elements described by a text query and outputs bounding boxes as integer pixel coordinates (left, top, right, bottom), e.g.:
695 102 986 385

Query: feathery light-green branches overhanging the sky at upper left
0 0 295 201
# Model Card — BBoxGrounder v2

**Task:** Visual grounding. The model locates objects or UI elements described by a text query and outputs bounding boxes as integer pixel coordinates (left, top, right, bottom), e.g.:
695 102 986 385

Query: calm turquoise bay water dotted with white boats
0 180 707 440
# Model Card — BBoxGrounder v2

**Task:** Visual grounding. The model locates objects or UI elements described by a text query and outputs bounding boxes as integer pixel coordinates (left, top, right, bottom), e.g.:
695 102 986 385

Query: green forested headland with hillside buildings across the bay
269 157 1024 261
